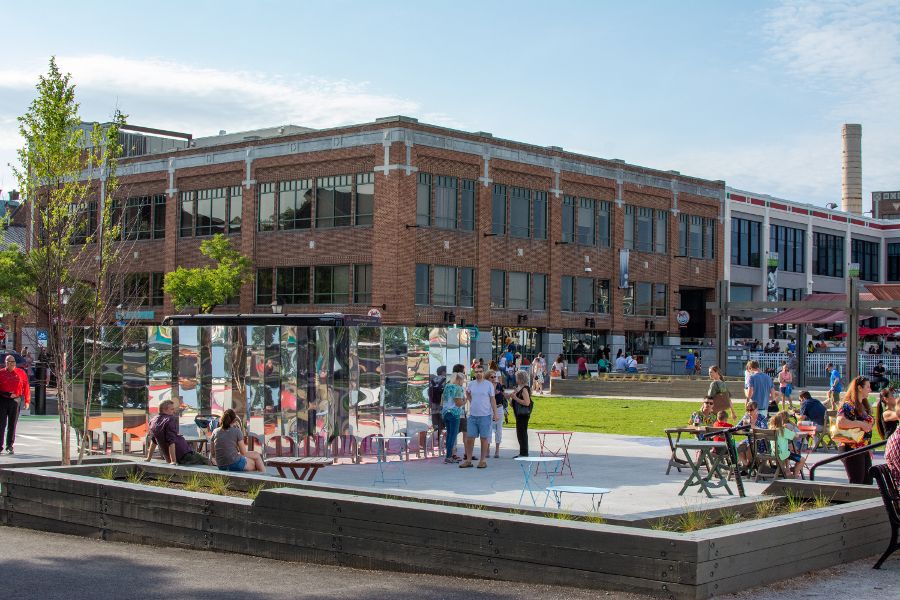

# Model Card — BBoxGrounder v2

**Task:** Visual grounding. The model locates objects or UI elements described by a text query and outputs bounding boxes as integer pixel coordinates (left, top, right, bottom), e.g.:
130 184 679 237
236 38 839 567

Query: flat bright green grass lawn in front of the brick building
524 396 700 437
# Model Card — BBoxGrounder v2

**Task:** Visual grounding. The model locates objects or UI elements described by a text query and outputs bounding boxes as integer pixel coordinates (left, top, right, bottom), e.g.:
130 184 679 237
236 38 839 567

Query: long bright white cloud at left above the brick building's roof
0 54 460 188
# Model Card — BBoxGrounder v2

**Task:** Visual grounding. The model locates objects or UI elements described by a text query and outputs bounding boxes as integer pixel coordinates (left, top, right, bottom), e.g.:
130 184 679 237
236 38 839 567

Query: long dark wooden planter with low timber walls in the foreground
0 463 889 599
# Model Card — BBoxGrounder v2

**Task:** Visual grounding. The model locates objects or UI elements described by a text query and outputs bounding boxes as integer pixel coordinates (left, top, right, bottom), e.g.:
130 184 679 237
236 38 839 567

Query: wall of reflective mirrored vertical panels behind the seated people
68 325 471 452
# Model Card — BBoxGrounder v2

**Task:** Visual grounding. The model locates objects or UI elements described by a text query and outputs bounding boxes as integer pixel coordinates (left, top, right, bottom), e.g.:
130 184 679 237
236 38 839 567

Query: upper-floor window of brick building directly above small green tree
183 186 241 237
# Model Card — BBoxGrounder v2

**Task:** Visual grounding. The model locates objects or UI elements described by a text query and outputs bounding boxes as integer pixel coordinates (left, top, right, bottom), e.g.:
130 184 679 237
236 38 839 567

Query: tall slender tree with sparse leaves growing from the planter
11 58 125 464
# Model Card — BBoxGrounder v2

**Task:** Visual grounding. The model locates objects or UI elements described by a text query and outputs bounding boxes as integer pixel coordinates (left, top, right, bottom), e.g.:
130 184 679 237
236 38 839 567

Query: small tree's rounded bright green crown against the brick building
163 234 252 313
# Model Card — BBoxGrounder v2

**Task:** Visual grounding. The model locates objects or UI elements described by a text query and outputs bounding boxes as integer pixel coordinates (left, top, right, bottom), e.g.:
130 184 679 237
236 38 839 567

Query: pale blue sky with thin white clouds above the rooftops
0 0 900 208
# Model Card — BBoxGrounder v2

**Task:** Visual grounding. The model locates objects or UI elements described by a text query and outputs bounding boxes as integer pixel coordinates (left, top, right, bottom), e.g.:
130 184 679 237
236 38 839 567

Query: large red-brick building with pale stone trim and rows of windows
21 117 727 358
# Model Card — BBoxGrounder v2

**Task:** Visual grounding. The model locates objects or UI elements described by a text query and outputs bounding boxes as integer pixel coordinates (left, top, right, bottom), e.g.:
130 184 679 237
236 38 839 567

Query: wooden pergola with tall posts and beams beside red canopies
707 276 900 386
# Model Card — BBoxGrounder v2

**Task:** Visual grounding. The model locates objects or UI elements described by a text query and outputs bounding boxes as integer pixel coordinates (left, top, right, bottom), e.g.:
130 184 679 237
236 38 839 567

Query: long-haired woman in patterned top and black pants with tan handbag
831 376 875 485
